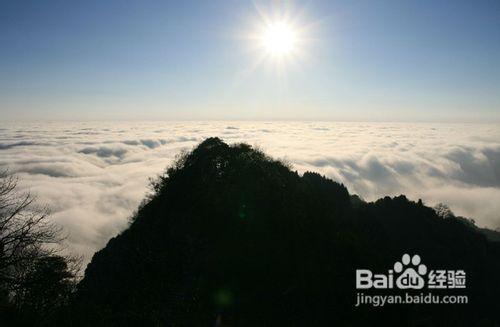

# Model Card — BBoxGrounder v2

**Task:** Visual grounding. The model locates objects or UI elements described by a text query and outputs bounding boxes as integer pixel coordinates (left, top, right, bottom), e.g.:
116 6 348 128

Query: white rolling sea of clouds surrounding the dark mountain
0 122 500 261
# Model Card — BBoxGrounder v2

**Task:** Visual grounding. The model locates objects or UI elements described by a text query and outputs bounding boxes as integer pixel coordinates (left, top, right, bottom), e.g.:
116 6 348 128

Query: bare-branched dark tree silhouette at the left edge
0 172 80 326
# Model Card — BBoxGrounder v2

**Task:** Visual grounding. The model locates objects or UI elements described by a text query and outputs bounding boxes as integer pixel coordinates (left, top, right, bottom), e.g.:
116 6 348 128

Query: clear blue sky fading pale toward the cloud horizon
0 0 500 122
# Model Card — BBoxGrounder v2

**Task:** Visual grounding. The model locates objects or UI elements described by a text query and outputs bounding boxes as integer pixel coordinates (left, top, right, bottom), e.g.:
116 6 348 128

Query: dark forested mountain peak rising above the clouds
69 138 500 326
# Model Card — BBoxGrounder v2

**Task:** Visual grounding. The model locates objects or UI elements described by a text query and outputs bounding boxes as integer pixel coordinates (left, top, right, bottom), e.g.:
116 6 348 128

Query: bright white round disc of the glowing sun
261 21 297 57
